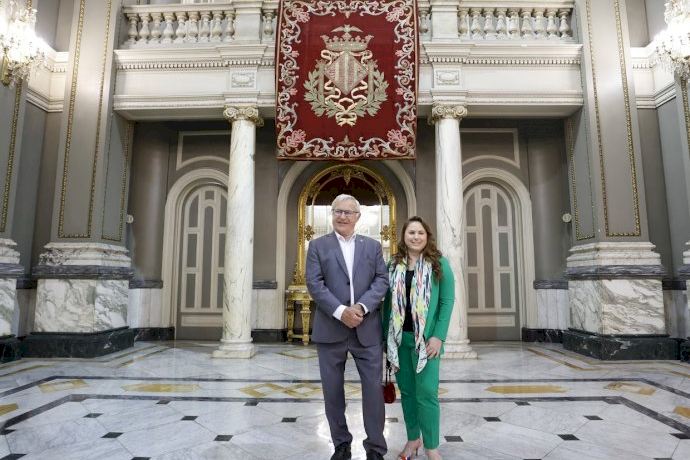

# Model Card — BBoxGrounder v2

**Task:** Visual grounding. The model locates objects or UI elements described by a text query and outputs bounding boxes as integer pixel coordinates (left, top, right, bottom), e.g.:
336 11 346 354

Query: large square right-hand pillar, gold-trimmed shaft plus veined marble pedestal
563 0 678 359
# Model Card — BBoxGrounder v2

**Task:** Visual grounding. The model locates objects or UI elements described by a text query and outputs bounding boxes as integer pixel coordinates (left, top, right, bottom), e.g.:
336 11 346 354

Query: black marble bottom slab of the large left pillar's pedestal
21 327 136 358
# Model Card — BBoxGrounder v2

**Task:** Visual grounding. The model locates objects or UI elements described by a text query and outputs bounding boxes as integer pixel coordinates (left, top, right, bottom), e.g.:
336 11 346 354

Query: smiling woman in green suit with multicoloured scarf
383 216 455 460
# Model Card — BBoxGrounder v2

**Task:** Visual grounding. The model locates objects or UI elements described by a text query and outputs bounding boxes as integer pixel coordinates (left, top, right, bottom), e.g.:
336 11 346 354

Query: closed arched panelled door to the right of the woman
463 168 535 341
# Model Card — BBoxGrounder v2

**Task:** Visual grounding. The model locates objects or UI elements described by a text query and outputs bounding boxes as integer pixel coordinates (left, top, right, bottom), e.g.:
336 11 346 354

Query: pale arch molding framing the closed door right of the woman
462 168 537 327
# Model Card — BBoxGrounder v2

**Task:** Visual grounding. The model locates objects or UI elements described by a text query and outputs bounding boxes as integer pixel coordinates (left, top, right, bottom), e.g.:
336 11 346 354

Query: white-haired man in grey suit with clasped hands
306 195 388 460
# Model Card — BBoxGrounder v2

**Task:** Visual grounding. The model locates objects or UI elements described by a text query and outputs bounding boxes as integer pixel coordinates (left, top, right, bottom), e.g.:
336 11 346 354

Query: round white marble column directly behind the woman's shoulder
431 104 477 358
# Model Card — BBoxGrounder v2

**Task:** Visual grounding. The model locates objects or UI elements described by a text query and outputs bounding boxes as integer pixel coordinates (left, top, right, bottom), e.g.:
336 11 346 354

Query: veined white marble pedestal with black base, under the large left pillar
23 243 135 357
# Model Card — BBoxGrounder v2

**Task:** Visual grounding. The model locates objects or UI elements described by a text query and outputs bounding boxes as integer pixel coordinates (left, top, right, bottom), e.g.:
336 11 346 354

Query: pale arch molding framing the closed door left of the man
161 168 228 326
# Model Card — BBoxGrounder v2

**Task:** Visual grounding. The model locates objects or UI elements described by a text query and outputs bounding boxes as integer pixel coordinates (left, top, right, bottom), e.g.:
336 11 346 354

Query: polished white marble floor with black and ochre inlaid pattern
0 342 690 460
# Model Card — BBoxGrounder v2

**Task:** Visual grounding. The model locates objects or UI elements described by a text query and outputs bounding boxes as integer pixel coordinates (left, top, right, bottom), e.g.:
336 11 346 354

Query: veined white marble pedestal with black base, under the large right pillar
563 242 678 359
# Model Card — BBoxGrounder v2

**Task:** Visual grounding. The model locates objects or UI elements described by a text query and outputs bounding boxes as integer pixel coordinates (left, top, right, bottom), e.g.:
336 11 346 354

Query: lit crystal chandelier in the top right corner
654 0 690 80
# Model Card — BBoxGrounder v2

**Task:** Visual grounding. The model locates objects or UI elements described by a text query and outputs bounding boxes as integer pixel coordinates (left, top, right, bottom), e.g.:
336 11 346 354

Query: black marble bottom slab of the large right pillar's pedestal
563 329 679 361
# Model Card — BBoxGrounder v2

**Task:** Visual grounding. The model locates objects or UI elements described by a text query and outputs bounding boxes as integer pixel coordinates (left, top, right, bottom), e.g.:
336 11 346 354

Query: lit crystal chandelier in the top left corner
0 0 45 86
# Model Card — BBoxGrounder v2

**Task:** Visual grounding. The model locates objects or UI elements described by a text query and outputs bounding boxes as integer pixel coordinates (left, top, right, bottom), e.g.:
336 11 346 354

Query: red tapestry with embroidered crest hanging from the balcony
276 0 418 161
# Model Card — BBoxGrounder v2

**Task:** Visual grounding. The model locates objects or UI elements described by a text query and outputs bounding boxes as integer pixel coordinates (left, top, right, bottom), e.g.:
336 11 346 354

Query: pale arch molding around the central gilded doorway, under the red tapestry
276 161 417 324
